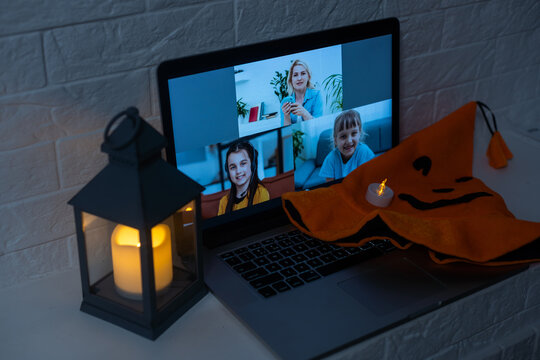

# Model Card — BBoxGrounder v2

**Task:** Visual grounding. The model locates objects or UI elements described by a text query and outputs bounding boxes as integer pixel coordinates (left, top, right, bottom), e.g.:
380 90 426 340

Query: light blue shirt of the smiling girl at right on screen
319 143 375 179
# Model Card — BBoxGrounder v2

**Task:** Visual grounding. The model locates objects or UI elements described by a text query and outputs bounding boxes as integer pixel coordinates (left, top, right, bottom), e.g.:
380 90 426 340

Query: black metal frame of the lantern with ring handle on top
68 108 208 340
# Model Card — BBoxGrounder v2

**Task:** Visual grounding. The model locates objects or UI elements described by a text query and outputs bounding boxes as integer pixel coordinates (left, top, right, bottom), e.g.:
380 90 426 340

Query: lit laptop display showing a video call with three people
168 35 392 218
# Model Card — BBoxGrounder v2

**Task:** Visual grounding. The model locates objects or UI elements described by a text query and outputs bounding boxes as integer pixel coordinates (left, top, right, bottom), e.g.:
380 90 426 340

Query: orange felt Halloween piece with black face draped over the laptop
282 102 540 265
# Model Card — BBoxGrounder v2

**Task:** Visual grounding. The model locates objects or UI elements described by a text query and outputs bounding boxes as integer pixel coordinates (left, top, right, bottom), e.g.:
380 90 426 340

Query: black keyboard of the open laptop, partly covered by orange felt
220 230 395 298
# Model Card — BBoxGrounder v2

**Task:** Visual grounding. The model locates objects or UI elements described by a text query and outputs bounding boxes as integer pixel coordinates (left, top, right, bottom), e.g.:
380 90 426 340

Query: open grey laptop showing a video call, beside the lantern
157 18 525 359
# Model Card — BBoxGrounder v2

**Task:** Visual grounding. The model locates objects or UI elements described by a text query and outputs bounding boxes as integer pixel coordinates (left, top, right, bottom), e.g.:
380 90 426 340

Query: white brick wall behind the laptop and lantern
0 0 540 359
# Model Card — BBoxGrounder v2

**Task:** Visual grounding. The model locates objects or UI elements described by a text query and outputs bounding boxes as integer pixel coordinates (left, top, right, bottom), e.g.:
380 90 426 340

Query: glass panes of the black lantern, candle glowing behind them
82 201 199 312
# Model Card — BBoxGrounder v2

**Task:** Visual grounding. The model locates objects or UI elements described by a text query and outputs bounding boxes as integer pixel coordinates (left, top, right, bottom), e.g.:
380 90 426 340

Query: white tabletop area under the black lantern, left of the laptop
0 270 274 360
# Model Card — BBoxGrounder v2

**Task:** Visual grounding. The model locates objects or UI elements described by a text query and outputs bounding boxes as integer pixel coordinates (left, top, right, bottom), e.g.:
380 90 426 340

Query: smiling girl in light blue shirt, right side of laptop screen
319 110 375 181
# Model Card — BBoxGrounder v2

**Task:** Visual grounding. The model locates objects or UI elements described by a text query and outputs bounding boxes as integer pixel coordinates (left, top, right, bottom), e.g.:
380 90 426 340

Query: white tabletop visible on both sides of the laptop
0 121 540 360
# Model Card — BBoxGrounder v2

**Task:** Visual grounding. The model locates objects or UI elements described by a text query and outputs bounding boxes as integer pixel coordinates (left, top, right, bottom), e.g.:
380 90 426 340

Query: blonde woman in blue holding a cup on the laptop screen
281 59 323 126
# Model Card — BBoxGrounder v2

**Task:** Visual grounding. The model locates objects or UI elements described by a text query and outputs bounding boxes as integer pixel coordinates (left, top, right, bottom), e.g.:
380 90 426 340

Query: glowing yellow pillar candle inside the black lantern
111 224 173 300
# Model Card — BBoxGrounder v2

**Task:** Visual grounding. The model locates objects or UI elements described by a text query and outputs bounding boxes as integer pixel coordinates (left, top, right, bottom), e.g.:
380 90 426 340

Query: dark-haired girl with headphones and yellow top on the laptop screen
218 140 270 215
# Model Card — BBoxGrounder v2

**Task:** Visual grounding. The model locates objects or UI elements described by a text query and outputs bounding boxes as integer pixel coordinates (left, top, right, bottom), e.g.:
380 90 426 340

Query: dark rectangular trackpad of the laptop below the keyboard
338 258 445 315
